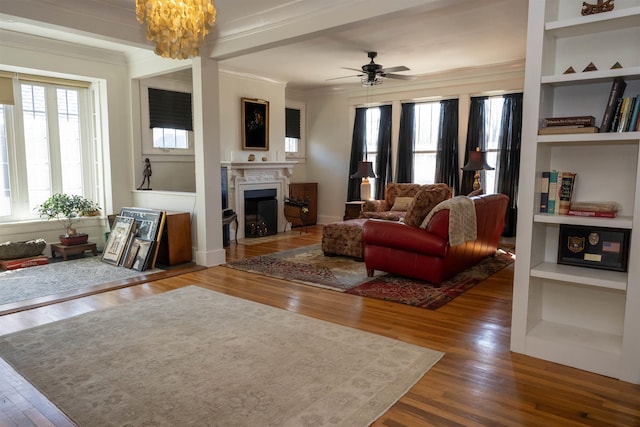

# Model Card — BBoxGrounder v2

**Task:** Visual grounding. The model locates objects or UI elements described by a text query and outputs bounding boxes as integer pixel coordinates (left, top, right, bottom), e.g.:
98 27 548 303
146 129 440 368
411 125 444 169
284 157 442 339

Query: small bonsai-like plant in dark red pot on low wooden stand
36 193 100 245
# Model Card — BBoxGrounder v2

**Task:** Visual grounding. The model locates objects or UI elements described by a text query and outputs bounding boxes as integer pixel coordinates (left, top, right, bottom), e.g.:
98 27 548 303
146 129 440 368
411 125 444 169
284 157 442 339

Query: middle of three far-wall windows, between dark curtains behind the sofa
413 102 440 184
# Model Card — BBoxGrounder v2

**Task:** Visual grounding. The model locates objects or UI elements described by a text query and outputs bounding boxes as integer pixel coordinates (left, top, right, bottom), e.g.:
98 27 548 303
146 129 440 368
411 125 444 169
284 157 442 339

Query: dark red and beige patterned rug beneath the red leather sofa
225 244 514 310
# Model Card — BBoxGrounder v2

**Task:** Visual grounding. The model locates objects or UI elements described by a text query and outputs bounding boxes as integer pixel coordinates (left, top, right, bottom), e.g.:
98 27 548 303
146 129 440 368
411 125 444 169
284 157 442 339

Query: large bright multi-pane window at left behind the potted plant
0 81 97 222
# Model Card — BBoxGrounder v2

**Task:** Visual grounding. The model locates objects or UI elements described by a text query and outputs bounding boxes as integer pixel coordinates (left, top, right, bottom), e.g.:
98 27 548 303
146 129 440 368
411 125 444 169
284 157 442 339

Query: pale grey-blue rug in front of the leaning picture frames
0 257 162 307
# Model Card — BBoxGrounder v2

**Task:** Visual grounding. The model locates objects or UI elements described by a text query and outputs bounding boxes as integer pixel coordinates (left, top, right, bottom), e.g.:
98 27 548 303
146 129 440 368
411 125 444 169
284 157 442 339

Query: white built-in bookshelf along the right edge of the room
511 0 640 384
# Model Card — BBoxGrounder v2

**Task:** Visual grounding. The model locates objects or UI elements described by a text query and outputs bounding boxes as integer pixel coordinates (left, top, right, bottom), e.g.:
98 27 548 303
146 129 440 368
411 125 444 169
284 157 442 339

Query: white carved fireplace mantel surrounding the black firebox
221 161 297 238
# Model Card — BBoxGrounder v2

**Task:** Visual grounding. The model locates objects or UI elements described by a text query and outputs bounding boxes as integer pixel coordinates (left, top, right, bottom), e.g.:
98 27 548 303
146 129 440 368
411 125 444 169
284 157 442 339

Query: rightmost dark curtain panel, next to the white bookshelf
496 93 522 237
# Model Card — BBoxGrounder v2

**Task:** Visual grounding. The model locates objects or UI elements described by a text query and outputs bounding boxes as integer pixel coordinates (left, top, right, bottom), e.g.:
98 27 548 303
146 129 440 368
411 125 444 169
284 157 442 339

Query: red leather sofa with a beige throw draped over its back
362 194 509 285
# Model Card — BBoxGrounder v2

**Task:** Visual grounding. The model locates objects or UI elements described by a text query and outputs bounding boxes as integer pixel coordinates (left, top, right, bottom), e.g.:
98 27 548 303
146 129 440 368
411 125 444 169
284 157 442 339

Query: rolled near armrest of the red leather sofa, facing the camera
362 219 448 257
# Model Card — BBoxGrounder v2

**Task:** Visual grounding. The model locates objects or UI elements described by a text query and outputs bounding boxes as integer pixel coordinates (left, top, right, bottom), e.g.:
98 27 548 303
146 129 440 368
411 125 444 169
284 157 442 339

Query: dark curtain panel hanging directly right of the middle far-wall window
436 99 460 190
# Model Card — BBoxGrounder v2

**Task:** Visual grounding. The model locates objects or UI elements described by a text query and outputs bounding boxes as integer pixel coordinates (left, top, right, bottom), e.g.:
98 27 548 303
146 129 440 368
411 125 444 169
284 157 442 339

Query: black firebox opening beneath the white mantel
244 188 278 237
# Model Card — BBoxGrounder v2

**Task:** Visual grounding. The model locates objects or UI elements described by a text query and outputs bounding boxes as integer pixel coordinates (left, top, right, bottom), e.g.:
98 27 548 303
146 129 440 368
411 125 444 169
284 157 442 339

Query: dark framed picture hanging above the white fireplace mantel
241 98 269 151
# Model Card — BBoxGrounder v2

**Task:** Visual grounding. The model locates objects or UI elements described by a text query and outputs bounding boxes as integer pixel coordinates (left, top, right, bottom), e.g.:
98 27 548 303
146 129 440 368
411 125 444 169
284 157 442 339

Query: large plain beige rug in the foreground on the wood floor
0 286 443 427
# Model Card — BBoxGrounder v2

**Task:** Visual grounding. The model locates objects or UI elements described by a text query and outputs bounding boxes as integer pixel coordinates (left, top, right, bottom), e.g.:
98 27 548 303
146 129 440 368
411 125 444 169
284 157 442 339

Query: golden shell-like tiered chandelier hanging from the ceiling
136 0 216 59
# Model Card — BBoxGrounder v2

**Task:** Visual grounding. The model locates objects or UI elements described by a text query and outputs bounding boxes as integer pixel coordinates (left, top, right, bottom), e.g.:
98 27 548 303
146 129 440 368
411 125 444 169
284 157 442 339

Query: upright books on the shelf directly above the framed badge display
540 170 576 215
